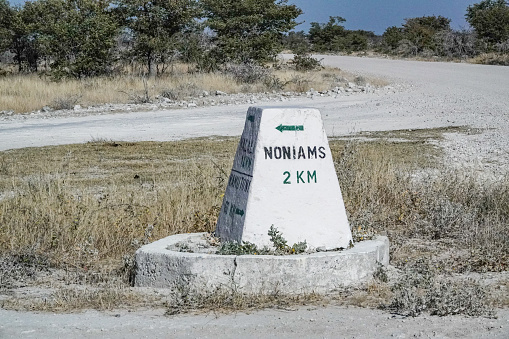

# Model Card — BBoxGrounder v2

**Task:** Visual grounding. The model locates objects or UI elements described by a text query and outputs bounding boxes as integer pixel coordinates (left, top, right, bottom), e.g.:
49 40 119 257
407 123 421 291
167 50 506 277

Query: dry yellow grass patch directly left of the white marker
0 139 235 267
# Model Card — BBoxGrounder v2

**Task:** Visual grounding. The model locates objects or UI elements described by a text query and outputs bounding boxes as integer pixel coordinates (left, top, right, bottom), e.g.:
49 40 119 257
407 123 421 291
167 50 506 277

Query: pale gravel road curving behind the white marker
0 56 509 175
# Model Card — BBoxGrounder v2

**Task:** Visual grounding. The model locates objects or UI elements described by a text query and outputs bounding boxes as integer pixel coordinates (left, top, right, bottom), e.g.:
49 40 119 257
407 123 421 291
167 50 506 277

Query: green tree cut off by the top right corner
465 0 509 45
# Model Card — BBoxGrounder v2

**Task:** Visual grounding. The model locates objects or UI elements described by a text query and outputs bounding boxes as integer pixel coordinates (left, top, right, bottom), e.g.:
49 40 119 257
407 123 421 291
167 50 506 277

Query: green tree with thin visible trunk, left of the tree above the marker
115 0 199 76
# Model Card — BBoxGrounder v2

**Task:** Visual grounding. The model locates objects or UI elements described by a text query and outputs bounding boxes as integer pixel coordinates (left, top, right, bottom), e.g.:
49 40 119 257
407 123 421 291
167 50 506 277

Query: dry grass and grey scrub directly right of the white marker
336 135 509 272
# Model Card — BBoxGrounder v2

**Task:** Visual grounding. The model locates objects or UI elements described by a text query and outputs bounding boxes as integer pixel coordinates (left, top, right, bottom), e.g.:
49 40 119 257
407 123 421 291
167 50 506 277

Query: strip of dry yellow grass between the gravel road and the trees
0 65 386 113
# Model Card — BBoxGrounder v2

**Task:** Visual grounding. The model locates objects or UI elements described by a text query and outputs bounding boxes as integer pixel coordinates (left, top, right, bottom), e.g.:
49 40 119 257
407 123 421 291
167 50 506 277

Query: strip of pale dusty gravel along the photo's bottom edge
0 307 509 339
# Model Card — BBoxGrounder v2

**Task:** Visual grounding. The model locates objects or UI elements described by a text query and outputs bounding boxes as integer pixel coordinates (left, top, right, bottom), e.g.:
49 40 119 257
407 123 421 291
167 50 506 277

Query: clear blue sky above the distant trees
6 0 481 34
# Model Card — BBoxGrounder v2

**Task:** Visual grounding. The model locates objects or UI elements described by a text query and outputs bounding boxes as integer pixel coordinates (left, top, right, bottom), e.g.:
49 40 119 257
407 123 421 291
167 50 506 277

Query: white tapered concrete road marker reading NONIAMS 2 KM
216 107 352 249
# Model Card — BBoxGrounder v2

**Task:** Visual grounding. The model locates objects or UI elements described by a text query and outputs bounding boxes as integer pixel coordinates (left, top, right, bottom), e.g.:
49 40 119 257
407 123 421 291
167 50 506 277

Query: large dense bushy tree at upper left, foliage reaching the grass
23 0 120 78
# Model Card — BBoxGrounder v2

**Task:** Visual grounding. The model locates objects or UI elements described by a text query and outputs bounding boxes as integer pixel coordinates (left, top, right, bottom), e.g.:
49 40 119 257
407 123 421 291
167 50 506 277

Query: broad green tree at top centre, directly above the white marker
202 0 302 63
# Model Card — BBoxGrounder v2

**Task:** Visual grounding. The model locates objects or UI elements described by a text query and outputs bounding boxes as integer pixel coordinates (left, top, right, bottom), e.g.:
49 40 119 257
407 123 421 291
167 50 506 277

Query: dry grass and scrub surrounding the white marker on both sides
0 129 509 313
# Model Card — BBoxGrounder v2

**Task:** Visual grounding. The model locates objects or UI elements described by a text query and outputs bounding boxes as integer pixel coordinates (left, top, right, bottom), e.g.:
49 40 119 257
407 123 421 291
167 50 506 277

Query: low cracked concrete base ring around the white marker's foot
135 233 389 294
